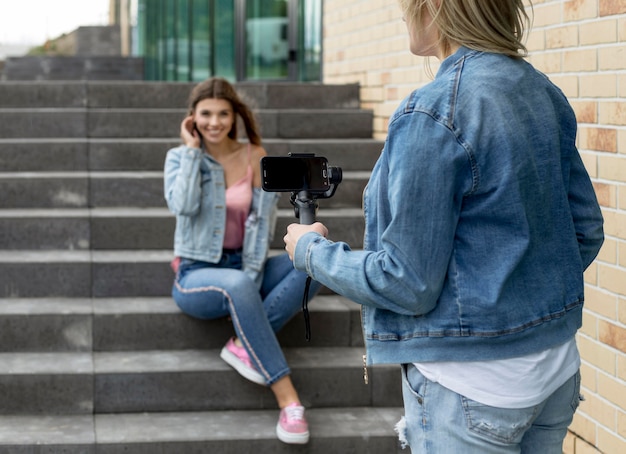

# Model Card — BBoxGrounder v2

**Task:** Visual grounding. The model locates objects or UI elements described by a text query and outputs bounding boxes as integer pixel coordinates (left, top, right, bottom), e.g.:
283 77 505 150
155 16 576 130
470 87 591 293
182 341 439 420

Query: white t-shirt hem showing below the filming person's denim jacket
415 338 580 408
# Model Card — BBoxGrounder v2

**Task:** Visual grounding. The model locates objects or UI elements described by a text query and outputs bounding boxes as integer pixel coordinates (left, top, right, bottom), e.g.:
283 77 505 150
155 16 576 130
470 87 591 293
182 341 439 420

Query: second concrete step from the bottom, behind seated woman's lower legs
0 347 401 415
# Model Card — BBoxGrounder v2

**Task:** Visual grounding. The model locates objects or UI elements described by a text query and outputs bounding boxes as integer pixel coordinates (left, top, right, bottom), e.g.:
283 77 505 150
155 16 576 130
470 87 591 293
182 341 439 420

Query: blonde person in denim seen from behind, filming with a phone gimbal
285 0 604 454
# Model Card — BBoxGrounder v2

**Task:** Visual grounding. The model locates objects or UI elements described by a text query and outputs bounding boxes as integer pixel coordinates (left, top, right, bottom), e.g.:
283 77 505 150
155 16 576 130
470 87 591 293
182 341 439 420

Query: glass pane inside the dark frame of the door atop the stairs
245 0 289 80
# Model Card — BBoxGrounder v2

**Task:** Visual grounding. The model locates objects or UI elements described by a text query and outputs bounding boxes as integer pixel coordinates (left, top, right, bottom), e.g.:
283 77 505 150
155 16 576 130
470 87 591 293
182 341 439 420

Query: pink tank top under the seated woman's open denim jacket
223 145 254 249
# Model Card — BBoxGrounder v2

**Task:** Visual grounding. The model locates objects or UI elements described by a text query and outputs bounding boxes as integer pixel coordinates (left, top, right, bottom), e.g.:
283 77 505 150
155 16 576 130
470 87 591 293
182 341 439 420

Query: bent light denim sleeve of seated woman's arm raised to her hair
163 146 202 216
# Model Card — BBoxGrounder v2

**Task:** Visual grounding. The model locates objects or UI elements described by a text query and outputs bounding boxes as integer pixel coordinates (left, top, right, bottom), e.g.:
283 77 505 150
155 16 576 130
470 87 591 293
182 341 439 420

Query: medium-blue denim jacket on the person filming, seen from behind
294 48 604 364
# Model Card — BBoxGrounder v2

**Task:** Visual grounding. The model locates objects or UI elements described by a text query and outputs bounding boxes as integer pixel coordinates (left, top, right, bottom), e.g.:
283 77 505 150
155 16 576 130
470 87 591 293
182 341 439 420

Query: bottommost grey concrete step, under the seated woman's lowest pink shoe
0 407 403 454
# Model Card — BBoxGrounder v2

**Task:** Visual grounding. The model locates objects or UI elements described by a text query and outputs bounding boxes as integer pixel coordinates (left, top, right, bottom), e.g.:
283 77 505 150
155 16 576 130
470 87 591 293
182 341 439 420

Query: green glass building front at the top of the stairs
130 0 322 81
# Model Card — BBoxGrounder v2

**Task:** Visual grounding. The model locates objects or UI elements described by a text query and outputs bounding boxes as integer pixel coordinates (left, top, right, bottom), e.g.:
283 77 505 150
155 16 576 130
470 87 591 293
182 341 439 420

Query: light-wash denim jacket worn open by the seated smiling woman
164 146 280 286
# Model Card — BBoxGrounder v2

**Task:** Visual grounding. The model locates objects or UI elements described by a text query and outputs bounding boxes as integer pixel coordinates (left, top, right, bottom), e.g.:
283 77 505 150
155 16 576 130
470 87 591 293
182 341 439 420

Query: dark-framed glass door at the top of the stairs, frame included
235 0 298 81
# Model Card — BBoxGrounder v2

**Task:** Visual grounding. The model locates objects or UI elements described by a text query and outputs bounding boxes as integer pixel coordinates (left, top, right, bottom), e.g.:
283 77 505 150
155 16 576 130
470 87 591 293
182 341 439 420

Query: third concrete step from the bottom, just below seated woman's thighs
0 294 363 353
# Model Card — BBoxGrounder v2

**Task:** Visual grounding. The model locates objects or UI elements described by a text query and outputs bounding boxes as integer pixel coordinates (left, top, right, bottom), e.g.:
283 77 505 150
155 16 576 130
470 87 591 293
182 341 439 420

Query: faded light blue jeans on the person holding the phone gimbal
399 364 580 454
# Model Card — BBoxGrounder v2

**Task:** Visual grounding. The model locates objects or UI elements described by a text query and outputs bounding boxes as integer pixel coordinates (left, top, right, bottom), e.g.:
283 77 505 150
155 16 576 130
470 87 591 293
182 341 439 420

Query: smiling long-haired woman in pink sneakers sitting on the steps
164 78 319 444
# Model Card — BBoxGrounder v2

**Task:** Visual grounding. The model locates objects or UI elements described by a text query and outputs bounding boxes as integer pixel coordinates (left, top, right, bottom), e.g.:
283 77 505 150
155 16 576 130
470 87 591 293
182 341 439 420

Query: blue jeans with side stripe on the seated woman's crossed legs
172 252 319 385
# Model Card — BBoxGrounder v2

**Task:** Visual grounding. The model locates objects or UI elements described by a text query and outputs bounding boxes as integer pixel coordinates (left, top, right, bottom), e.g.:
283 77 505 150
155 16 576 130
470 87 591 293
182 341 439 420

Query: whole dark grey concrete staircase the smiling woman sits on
0 81 402 454
